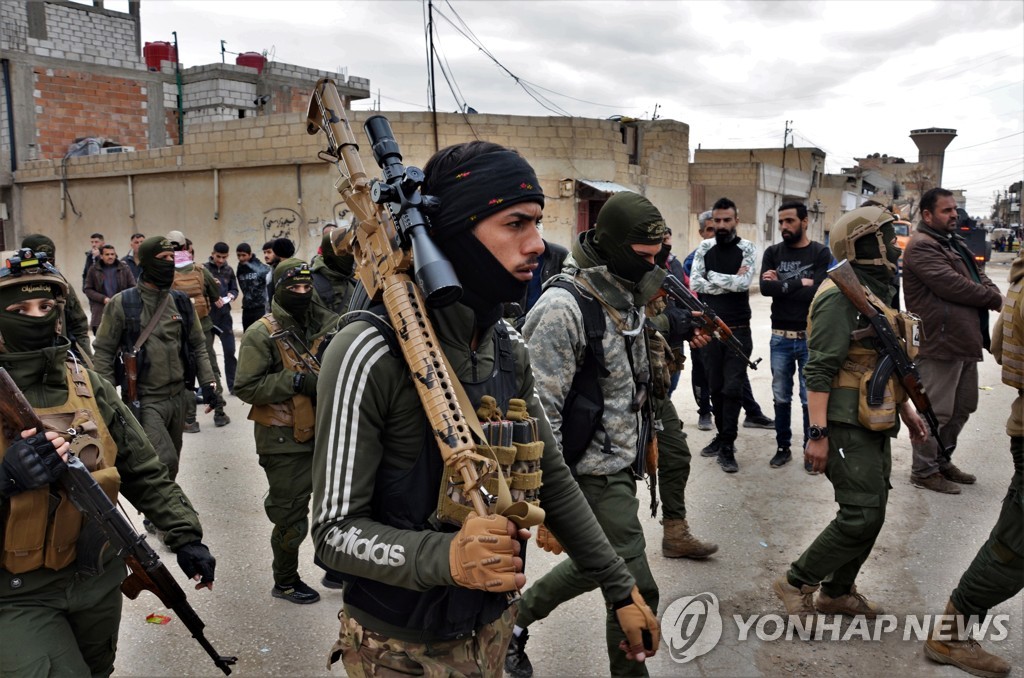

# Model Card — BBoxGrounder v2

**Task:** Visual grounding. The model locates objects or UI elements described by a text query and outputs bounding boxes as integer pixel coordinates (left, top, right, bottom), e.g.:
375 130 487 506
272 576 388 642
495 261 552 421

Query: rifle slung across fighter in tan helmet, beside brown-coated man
828 259 953 460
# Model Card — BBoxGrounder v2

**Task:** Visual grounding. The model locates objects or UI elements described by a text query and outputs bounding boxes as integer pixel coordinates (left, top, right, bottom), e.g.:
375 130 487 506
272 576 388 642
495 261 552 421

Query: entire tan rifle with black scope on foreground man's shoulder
306 78 543 527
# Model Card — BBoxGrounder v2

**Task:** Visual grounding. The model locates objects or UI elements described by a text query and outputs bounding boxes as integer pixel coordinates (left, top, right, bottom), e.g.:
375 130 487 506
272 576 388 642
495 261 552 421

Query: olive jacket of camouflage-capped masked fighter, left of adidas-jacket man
234 301 338 455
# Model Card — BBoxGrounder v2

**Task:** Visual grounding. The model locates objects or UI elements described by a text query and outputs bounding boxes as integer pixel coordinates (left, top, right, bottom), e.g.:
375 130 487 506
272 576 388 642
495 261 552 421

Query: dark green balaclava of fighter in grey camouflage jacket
593 192 668 284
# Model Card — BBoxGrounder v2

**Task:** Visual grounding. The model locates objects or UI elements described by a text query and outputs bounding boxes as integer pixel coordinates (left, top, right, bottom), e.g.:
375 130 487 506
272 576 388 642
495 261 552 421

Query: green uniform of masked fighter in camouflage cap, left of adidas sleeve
234 259 336 587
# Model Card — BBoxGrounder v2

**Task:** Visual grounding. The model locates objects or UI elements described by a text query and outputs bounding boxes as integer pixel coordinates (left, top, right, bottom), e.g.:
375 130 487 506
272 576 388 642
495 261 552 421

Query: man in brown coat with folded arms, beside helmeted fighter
903 188 1002 495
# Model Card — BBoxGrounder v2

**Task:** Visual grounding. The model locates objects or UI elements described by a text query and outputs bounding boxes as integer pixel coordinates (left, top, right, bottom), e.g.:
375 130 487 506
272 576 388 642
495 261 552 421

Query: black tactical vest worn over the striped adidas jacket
343 311 517 642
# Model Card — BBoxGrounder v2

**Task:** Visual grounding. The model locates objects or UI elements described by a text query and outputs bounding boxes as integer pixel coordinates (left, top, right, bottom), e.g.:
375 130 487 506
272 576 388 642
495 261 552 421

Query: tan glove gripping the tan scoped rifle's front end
449 511 521 592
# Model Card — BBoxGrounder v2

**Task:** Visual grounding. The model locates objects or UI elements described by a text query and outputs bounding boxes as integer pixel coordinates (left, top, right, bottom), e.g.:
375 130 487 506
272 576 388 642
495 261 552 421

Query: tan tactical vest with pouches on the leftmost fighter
0 363 121 575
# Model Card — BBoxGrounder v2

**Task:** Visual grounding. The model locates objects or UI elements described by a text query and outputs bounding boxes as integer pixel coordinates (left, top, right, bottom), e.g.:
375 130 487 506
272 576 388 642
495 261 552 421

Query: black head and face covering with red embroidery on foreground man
423 149 544 327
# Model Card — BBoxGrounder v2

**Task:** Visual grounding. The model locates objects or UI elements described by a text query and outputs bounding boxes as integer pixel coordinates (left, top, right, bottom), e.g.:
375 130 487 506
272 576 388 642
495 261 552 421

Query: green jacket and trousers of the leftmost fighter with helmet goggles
0 333 203 676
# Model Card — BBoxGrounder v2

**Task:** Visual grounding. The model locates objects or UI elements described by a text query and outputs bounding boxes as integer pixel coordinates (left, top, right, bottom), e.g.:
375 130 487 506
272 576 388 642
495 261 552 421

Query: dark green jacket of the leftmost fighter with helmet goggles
0 340 203 599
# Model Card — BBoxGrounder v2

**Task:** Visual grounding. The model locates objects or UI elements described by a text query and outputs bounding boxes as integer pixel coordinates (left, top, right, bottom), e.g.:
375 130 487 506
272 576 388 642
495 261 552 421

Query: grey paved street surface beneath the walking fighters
116 254 1024 677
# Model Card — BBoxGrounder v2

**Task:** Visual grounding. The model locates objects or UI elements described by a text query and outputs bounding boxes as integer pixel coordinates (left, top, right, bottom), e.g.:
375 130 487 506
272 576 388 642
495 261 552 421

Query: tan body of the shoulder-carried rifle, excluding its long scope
306 78 512 515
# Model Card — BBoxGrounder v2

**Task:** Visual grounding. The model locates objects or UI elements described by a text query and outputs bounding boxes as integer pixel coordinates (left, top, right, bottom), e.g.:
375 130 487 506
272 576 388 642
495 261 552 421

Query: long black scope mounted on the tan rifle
362 116 462 308
